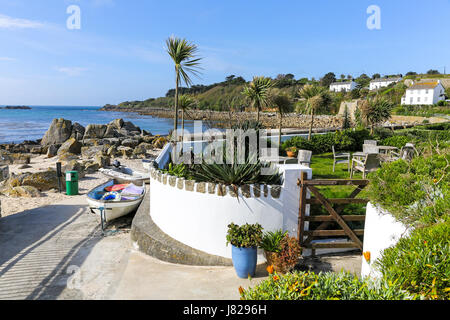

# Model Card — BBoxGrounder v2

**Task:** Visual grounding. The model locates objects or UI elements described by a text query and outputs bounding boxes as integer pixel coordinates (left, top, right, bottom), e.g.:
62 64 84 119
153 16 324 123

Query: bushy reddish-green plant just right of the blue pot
261 230 301 273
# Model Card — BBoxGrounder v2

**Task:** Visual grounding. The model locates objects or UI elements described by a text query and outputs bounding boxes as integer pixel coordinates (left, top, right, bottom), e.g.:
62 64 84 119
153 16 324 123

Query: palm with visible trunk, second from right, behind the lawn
298 84 331 140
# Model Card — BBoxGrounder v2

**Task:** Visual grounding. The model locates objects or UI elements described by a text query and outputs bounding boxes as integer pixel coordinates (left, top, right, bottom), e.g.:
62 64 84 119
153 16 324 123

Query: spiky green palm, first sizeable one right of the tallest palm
242 77 273 122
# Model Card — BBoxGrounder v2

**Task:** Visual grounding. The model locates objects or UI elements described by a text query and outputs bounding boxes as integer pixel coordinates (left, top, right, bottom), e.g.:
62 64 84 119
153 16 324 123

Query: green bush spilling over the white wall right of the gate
367 154 450 225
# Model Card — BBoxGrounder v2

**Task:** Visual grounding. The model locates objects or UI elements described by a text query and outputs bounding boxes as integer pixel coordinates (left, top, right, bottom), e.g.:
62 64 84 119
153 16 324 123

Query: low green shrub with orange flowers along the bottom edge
240 272 412 300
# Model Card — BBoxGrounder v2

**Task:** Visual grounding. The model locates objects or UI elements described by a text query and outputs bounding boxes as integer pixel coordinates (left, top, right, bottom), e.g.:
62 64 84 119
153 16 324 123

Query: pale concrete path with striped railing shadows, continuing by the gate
0 197 361 300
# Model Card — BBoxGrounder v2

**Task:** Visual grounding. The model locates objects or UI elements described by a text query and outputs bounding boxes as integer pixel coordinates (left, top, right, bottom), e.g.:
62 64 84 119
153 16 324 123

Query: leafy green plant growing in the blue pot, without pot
227 223 262 248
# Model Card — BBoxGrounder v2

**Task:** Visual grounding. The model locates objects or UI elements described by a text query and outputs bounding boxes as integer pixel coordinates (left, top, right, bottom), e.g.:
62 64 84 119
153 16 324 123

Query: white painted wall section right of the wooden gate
361 202 410 278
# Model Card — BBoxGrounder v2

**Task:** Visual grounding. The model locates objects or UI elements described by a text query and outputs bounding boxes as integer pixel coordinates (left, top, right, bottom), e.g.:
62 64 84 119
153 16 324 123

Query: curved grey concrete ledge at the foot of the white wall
131 188 233 266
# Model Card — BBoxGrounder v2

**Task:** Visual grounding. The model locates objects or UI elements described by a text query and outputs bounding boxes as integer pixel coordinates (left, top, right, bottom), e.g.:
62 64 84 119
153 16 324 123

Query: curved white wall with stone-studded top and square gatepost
150 164 312 258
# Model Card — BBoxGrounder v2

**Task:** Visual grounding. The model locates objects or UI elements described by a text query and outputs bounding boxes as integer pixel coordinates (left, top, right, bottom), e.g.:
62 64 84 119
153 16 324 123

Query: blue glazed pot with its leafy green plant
227 223 262 279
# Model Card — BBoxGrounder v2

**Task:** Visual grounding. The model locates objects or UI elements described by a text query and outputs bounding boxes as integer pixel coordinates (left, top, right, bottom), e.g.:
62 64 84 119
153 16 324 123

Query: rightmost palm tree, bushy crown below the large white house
360 97 394 134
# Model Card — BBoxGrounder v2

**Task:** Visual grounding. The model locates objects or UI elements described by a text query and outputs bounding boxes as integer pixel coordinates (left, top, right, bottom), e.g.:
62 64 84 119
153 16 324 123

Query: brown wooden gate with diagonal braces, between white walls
297 172 369 255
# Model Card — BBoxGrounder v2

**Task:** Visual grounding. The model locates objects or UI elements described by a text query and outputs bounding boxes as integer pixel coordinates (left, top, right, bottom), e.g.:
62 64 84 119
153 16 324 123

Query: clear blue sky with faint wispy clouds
0 0 450 106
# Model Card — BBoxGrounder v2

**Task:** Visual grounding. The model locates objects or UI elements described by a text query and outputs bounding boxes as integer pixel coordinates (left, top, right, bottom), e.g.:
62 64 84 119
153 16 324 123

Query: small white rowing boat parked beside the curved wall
87 179 146 226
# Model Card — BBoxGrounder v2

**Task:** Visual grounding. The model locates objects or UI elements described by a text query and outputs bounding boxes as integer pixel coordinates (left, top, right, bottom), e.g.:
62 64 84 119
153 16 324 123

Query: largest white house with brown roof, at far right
402 80 445 105
